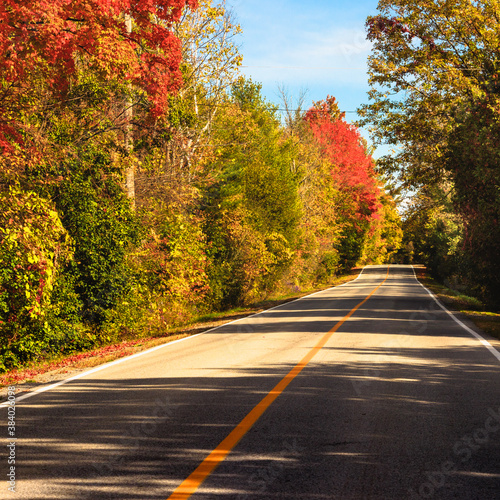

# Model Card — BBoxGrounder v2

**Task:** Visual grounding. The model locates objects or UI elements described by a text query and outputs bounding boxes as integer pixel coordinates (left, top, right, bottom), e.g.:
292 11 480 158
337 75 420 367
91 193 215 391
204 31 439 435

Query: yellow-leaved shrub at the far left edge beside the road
0 187 72 370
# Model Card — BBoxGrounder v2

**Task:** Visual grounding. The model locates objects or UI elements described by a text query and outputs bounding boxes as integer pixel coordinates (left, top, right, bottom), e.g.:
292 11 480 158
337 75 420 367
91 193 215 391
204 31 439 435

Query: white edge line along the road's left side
0 266 366 408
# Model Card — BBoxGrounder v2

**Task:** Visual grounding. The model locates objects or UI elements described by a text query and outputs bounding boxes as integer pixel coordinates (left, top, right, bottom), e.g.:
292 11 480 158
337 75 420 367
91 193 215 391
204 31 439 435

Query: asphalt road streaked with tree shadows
0 266 500 500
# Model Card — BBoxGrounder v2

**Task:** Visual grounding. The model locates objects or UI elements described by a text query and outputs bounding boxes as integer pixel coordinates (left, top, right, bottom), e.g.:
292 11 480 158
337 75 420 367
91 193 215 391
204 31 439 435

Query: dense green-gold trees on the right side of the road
362 0 500 307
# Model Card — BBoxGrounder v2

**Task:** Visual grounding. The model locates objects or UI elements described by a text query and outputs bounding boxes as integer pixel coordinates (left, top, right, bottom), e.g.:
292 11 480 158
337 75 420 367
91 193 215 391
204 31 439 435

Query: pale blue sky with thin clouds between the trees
227 0 382 156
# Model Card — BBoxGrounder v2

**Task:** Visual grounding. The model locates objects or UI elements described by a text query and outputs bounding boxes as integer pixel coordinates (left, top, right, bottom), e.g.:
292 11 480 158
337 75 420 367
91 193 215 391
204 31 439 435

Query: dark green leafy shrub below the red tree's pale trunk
55 151 143 327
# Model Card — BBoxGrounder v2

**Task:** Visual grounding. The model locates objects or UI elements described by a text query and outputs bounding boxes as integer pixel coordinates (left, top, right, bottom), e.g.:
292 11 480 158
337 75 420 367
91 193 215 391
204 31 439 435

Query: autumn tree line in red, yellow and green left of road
0 0 402 371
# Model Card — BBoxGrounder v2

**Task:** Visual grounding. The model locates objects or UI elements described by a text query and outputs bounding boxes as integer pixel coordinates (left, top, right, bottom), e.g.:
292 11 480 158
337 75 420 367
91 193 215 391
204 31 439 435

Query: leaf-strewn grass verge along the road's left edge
0 268 360 390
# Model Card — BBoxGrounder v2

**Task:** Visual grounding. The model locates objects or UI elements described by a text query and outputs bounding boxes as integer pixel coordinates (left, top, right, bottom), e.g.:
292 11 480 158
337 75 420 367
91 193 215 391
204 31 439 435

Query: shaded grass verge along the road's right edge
415 266 500 339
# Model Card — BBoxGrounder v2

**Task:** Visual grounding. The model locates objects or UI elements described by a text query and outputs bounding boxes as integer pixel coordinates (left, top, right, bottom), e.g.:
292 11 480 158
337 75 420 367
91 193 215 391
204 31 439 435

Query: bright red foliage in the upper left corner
0 0 197 149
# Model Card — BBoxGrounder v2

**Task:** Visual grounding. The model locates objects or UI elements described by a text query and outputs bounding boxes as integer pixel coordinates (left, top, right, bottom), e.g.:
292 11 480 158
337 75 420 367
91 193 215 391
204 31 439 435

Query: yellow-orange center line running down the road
167 266 390 500
